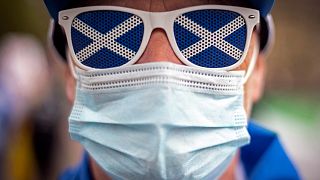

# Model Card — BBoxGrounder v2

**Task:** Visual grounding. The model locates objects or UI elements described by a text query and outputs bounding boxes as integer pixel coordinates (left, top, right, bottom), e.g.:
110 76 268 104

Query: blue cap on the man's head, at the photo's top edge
43 0 275 21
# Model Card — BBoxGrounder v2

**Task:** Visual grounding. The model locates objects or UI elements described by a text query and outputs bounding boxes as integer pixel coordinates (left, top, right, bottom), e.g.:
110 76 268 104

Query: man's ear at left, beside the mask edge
65 68 76 104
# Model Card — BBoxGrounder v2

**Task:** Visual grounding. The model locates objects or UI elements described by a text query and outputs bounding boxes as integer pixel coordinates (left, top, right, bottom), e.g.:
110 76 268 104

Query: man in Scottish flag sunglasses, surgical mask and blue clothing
44 0 299 179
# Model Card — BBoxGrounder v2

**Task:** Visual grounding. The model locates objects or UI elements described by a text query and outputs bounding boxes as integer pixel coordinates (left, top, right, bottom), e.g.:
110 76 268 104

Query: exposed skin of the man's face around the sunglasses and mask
68 0 264 115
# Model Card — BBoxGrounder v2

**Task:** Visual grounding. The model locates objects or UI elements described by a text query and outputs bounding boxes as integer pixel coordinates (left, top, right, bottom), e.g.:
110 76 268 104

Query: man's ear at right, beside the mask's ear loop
249 53 266 103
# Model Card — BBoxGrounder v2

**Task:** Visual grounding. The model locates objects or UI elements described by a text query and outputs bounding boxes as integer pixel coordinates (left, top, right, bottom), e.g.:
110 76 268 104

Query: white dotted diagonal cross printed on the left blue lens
72 16 142 62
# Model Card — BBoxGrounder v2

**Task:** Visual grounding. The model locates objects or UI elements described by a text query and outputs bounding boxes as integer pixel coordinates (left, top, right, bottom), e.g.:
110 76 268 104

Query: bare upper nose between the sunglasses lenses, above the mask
136 29 183 64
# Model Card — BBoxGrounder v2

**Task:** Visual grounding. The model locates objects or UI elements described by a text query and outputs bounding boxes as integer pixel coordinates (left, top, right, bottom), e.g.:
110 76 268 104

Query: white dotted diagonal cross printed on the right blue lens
175 15 245 60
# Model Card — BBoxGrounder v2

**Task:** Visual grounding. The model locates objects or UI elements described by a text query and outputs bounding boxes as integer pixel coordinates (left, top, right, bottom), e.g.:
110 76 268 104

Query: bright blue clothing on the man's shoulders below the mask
60 122 300 180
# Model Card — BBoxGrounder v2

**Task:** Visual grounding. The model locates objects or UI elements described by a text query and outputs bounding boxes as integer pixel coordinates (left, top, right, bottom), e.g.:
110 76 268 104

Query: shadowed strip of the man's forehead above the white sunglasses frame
71 0 249 11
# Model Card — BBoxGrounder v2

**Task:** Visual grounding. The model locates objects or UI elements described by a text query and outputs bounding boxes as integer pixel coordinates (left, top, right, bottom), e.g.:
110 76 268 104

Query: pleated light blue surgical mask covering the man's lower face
69 62 250 179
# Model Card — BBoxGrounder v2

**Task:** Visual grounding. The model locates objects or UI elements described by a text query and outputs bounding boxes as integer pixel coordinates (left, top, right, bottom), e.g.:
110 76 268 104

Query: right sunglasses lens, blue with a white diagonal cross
174 9 247 68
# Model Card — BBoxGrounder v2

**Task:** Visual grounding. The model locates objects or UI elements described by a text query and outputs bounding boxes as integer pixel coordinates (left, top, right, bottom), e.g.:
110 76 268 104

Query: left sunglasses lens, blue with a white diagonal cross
71 10 144 69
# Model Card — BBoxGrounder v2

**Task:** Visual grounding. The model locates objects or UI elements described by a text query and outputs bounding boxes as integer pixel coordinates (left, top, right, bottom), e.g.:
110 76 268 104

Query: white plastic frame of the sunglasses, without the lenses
59 5 260 70
